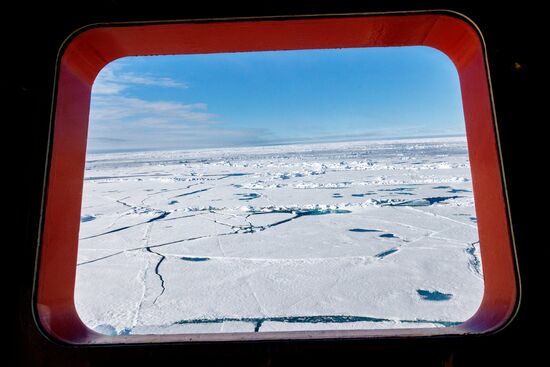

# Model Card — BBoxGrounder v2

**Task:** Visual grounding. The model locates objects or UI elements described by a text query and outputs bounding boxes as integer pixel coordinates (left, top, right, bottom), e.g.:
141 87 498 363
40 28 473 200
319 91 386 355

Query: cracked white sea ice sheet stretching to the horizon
75 138 483 335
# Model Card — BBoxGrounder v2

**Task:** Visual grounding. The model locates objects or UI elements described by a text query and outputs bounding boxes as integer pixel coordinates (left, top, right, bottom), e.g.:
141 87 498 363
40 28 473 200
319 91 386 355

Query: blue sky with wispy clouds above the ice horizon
88 47 464 152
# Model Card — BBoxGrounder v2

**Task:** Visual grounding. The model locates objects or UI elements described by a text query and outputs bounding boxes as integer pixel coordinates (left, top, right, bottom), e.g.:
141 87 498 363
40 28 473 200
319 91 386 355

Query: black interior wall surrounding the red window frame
8 0 548 366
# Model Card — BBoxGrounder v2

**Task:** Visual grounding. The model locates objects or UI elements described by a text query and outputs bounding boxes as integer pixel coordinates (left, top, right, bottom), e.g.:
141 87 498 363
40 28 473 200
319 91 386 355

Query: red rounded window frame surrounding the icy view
34 12 519 345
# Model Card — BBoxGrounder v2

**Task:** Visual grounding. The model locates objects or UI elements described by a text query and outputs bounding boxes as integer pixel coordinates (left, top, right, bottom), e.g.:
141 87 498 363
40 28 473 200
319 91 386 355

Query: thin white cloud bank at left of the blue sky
88 64 267 151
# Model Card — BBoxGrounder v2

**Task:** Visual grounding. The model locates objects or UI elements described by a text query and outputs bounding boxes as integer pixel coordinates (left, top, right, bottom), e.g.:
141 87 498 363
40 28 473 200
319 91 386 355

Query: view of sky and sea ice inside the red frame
75 47 483 335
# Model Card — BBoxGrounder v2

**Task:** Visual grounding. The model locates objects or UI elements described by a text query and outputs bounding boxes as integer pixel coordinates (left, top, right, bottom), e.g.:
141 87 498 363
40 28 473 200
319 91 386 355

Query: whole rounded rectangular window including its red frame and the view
36 14 516 344
